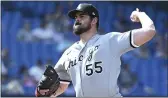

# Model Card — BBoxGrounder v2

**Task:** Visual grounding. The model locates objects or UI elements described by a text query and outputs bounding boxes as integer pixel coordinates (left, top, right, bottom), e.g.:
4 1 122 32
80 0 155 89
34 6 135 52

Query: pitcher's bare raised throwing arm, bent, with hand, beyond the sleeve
130 9 156 47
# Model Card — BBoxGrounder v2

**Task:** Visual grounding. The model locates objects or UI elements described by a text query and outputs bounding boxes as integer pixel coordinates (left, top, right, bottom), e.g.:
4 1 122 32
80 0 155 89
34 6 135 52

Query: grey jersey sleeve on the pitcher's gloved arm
54 49 71 82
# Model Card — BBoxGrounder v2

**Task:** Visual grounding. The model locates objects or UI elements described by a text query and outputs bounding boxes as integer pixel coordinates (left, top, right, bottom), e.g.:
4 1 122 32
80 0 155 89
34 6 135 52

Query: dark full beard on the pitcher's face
73 22 91 35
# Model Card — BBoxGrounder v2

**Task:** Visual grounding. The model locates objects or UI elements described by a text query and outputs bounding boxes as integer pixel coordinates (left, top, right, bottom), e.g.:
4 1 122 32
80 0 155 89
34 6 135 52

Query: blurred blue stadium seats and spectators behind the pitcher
1 1 168 97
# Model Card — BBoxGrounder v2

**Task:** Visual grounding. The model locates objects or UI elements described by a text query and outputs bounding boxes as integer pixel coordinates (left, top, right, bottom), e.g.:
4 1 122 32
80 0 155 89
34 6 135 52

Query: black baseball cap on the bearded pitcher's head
68 3 99 19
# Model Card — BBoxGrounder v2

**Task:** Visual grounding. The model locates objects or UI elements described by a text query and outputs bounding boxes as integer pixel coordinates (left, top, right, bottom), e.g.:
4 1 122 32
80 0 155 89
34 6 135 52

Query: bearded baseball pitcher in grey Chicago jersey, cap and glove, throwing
36 3 156 97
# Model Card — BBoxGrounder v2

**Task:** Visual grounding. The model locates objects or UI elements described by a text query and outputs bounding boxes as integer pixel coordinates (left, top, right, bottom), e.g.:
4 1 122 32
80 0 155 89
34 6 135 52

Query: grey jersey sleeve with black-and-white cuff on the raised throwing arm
110 31 139 55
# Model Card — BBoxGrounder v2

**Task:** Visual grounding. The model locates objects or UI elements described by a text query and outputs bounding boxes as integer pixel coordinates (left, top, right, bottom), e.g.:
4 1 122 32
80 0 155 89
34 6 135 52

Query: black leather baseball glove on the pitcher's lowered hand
35 65 60 97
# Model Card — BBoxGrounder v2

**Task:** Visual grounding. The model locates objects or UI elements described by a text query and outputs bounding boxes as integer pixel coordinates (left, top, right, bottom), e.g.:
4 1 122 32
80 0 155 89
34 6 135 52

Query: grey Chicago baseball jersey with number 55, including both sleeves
55 31 136 97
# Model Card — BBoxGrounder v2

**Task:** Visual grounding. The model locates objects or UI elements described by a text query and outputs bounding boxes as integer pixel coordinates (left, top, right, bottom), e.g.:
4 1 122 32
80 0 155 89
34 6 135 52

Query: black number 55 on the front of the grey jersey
86 61 103 76
